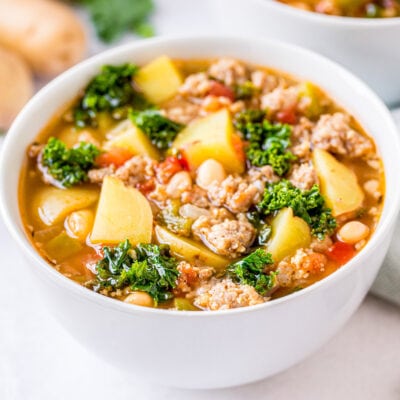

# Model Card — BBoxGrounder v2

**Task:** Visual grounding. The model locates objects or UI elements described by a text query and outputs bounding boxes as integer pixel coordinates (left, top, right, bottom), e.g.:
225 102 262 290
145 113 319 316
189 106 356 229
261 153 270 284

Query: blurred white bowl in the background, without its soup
214 0 400 105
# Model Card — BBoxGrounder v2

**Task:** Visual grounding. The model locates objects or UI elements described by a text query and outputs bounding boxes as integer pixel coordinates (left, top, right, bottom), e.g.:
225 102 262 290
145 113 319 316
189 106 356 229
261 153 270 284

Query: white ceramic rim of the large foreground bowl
0 36 400 318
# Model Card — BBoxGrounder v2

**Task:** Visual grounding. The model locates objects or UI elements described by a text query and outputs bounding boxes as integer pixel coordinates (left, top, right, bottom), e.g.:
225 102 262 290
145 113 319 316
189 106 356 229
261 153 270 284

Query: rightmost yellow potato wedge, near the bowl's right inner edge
313 149 364 216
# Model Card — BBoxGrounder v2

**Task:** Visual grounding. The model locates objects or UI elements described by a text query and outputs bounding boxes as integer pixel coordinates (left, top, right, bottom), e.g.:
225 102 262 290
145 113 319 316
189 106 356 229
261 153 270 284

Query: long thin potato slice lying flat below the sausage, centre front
155 226 229 270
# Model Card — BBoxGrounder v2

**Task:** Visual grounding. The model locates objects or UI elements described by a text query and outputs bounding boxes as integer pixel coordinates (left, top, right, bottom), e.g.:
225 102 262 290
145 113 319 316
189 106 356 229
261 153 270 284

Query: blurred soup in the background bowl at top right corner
278 0 400 18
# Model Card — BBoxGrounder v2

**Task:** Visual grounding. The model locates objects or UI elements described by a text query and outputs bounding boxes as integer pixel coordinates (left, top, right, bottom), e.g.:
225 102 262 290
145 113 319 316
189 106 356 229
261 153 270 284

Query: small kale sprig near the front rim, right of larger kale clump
227 249 276 296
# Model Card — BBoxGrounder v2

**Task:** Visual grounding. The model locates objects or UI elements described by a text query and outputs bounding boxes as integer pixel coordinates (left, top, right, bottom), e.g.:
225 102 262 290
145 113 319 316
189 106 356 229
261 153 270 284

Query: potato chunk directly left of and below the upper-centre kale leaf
104 120 160 160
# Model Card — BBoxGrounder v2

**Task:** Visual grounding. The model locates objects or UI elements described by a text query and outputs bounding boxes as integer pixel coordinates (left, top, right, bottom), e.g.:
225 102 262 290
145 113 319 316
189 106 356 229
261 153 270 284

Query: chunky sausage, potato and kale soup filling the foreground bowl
20 56 384 311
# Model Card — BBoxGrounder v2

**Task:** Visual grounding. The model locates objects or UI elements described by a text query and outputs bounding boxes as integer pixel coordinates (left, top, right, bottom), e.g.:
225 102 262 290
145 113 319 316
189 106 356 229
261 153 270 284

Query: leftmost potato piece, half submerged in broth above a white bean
33 187 99 225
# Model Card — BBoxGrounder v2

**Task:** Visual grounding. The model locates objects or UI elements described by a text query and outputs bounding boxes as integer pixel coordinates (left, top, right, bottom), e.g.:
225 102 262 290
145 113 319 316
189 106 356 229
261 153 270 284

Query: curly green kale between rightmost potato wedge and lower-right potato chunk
257 180 336 239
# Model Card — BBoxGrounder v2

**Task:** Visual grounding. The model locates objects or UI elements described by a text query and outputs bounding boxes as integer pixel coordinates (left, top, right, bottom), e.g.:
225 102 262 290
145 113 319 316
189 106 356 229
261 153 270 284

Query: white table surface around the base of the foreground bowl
0 0 400 400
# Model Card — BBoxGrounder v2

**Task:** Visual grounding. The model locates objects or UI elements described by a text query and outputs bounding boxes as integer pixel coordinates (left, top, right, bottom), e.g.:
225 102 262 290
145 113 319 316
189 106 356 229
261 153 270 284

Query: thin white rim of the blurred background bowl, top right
255 0 400 29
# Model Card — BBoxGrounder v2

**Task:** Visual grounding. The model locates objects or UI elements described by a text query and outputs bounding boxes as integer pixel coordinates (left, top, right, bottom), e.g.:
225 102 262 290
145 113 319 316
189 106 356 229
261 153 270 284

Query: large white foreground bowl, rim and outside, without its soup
0 37 400 388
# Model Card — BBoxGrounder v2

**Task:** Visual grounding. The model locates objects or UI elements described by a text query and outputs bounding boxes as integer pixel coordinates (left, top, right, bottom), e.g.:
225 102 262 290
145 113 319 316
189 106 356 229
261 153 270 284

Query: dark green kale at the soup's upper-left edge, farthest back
74 64 150 127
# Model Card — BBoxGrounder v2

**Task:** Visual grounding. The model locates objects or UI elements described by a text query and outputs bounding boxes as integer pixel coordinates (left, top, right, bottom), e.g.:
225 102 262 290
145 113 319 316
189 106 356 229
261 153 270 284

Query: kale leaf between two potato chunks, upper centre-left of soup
129 110 184 150
